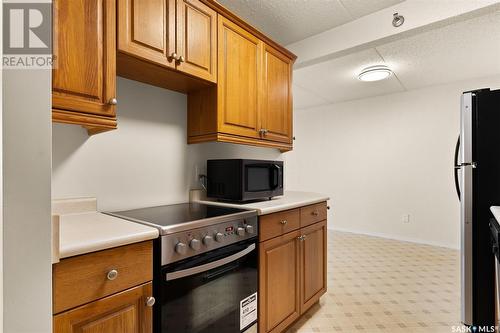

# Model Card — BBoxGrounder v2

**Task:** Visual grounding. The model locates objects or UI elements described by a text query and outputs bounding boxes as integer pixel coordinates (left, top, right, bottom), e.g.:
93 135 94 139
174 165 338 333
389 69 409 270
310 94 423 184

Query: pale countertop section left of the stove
52 199 159 262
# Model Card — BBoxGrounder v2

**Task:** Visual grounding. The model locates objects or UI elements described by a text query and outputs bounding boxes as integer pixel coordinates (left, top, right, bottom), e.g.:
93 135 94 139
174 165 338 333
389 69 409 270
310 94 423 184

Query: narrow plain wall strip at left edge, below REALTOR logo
2 70 52 333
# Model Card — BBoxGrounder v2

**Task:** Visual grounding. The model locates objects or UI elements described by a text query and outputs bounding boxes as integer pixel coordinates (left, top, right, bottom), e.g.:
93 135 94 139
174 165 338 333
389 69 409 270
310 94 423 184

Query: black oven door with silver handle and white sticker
158 238 258 333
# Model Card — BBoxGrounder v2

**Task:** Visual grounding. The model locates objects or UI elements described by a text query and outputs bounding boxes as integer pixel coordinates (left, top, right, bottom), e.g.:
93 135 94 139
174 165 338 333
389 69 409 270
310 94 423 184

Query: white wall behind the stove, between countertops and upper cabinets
52 78 286 210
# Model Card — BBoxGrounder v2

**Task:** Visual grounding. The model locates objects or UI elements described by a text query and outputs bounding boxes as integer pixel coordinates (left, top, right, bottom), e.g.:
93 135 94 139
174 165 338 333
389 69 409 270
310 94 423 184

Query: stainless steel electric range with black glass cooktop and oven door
108 203 258 333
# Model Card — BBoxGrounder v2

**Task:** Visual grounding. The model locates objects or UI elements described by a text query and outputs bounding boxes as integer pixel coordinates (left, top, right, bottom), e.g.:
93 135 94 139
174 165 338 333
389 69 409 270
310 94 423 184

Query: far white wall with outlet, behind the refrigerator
287 77 500 248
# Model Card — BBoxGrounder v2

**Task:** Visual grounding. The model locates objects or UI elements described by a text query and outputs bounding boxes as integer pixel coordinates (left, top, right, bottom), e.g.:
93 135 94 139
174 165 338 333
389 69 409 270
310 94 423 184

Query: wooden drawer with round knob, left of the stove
52 241 153 314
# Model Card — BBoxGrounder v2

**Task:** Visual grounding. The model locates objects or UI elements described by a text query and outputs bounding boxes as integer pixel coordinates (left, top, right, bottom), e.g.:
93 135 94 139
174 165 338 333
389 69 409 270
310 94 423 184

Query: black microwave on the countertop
207 159 283 201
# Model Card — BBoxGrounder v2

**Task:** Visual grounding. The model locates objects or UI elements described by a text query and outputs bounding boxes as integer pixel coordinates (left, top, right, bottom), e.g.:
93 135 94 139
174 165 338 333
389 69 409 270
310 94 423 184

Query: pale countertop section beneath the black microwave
191 190 330 215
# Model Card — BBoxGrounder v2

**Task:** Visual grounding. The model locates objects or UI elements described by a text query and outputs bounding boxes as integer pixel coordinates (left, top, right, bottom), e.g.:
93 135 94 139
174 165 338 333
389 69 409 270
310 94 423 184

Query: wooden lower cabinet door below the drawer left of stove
54 282 152 333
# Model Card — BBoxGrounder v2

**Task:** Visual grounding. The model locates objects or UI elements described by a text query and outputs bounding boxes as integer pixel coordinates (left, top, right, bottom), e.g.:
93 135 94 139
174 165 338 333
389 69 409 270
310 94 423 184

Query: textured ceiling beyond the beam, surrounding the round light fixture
294 11 500 109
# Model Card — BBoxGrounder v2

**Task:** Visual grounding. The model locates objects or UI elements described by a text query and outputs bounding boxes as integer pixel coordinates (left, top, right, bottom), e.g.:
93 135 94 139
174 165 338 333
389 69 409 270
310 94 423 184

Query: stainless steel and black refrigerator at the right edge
455 89 500 326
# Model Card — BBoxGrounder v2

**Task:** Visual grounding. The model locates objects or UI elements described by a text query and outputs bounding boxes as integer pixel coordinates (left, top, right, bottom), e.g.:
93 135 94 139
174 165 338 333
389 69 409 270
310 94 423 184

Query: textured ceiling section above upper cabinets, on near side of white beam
218 0 403 45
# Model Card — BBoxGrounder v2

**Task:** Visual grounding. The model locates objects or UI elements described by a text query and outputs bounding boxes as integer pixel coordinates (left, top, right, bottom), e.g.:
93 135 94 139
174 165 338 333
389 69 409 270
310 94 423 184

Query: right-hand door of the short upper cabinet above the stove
177 0 217 82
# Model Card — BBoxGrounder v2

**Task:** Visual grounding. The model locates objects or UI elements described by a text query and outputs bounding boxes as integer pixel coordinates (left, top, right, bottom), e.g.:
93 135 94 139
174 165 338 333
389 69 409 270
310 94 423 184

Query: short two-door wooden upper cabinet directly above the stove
118 0 217 82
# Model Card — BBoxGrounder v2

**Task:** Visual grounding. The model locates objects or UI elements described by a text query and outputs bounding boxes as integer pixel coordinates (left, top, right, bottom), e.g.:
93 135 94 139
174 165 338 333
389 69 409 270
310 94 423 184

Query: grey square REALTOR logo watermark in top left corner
2 1 55 69
